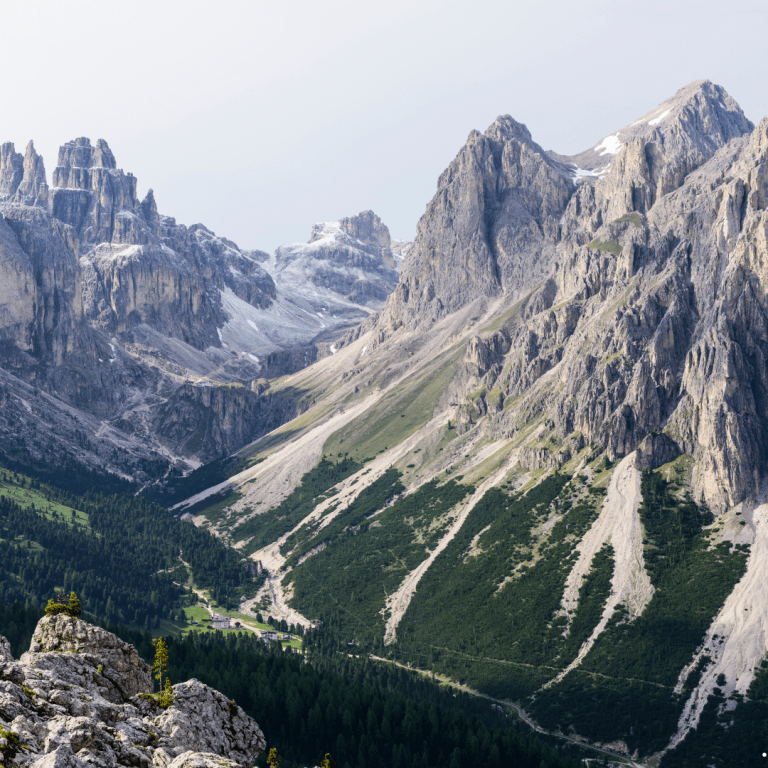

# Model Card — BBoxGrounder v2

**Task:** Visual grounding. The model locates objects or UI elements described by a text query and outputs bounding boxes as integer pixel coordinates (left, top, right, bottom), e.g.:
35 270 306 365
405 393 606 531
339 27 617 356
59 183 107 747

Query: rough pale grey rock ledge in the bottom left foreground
0 615 266 768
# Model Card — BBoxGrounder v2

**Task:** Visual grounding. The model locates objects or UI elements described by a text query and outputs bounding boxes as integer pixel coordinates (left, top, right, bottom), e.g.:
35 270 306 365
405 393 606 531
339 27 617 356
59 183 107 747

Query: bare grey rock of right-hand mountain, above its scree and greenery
358 81 768 510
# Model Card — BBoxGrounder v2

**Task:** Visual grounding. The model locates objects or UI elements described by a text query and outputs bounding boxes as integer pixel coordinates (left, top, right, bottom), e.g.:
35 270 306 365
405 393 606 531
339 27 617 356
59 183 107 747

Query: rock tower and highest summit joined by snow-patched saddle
376 80 754 332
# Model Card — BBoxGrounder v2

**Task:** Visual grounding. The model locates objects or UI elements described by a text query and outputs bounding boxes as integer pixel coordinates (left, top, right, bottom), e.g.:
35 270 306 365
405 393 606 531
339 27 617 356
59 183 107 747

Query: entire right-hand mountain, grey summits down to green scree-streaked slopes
178 81 768 759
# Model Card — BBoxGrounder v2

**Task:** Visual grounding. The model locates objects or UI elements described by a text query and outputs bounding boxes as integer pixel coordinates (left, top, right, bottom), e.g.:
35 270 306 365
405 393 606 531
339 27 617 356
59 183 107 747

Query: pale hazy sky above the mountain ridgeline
0 0 768 251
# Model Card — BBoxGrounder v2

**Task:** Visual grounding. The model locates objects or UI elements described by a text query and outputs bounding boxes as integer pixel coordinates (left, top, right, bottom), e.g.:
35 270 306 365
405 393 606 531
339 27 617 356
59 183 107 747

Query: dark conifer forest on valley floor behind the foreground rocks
0 603 580 768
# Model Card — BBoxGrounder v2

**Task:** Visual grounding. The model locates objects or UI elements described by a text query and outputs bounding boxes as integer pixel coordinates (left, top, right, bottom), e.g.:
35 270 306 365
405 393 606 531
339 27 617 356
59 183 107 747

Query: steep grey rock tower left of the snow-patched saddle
380 116 574 328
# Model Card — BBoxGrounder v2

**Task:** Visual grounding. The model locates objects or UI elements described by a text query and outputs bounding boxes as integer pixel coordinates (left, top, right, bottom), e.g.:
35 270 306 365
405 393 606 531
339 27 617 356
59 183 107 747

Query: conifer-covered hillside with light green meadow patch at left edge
0 470 259 629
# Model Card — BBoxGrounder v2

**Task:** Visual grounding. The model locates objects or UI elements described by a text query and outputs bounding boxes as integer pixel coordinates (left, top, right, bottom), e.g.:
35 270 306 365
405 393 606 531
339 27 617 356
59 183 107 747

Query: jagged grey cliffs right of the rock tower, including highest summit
426 81 768 510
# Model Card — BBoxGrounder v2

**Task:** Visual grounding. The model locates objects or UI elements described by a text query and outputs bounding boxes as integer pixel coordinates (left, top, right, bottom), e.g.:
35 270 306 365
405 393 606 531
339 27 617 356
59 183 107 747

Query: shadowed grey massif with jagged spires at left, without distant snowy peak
0 138 276 468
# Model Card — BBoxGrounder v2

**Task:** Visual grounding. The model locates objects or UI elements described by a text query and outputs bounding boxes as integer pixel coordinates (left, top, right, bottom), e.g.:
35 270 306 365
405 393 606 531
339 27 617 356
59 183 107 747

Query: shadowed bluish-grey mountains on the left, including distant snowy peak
0 138 407 474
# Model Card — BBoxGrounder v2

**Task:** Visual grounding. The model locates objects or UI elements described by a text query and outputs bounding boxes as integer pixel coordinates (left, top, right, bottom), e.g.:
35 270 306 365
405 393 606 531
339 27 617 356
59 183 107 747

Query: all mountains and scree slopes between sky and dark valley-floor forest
0 80 768 768
